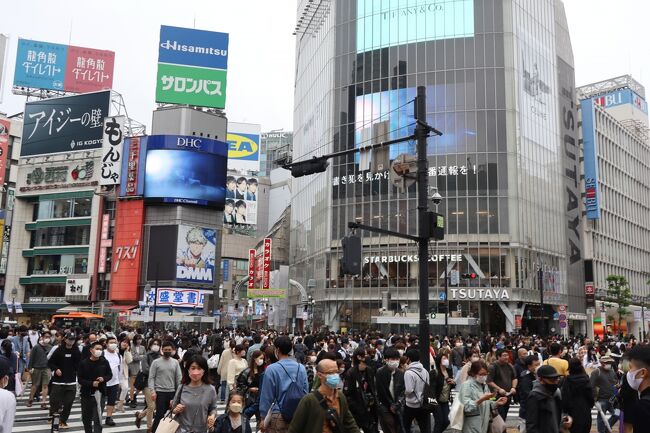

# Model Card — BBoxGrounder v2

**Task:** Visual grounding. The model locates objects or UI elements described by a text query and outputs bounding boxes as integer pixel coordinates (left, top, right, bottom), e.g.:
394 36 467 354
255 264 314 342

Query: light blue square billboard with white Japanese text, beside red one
14 39 68 90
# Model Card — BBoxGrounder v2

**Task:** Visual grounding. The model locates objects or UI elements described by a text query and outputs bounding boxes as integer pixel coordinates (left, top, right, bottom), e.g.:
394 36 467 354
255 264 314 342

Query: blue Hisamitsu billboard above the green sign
158 26 228 70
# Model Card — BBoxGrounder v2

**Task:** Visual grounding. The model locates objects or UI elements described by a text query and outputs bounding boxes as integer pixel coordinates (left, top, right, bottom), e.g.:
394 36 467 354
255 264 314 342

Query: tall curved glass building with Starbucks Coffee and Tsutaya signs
290 0 586 333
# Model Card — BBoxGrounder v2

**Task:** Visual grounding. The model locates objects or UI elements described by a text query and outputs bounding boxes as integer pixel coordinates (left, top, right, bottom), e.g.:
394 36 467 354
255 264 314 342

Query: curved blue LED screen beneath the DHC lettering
144 149 227 209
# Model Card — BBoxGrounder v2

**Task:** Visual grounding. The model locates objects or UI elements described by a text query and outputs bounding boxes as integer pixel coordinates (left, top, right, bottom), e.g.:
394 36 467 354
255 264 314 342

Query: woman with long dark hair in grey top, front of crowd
171 355 217 433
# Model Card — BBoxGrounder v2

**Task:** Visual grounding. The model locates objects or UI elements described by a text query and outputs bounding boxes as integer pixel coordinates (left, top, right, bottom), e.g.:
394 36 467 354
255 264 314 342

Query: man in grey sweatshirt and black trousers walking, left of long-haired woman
147 340 182 432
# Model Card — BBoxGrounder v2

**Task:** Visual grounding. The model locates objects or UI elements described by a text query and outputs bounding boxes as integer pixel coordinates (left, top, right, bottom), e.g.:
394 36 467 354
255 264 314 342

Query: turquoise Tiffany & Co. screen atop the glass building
357 0 474 53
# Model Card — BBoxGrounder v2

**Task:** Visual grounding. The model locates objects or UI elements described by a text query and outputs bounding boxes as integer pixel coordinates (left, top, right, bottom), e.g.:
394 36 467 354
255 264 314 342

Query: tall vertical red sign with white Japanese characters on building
110 200 144 301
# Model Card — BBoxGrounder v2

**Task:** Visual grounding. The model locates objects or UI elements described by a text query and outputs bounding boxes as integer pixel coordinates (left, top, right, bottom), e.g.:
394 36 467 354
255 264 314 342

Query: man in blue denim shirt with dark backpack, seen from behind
260 335 309 433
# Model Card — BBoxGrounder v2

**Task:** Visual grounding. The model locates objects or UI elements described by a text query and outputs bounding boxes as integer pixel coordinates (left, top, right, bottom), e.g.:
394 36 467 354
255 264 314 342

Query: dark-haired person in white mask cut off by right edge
625 344 650 433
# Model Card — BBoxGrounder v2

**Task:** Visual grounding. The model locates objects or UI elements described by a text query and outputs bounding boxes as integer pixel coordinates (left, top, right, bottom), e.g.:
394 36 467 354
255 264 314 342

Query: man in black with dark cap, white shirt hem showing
47 332 81 428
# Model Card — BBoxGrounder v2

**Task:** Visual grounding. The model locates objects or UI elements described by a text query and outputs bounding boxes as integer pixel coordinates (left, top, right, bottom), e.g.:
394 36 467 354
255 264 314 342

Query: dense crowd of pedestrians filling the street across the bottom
0 326 650 433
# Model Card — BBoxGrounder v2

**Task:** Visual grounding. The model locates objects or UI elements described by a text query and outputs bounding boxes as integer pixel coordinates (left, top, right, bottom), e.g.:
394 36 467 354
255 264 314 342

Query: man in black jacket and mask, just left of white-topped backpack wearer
375 347 404 433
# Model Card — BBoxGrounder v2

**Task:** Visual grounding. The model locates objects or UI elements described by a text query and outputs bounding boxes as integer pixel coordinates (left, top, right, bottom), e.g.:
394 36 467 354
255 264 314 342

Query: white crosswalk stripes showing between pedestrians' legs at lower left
11 396 255 433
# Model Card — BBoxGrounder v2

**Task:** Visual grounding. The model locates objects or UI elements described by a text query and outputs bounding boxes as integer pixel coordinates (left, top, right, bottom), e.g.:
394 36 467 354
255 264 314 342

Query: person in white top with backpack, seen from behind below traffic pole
404 347 429 433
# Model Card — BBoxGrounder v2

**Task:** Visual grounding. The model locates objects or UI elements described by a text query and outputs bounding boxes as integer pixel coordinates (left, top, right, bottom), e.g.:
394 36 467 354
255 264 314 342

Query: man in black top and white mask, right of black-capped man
77 343 113 433
